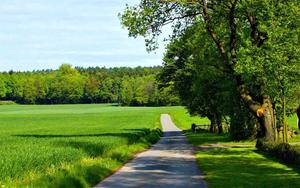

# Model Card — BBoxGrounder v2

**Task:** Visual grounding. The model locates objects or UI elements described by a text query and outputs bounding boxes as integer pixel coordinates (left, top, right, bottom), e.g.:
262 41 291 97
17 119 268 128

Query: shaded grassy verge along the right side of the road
170 108 300 187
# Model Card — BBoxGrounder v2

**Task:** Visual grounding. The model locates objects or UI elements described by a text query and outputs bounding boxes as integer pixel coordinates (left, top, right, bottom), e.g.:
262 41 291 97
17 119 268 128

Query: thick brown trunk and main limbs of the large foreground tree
201 0 276 141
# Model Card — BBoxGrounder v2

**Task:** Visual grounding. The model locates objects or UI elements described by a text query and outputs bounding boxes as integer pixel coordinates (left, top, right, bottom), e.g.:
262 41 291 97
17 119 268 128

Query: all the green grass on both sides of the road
0 105 300 187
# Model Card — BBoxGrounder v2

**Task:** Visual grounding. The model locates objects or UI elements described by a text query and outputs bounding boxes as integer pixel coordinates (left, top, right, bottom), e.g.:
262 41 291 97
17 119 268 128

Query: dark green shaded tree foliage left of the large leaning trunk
158 23 256 140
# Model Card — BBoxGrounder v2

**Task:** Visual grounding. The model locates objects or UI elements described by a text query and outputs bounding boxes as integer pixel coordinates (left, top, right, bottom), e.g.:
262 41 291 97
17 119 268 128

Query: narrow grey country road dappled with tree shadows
96 114 206 188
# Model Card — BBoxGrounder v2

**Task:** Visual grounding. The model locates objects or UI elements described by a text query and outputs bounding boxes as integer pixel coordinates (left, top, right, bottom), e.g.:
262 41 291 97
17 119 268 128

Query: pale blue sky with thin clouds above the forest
0 0 164 71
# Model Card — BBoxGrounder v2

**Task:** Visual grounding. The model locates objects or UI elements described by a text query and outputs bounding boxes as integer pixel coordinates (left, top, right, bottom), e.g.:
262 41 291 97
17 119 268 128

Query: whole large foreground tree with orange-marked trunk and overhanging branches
121 0 300 141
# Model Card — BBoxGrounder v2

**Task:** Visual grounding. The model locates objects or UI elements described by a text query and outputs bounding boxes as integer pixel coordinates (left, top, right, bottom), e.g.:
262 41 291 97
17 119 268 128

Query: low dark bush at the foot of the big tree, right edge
256 140 300 164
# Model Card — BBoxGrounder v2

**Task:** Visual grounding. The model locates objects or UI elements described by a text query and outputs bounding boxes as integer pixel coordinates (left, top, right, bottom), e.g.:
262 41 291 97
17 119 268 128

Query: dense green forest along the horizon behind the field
0 64 179 106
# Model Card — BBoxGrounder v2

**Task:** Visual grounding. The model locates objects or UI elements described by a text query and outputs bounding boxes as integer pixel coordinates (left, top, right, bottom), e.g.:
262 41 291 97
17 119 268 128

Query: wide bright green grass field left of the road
0 105 185 187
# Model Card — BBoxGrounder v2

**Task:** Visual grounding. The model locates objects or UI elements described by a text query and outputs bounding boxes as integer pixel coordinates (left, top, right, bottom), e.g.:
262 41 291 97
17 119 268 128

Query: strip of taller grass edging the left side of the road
26 124 161 188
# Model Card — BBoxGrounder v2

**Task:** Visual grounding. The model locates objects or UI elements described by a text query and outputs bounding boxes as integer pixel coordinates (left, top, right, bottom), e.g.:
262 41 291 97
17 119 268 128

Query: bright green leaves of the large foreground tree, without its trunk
121 0 300 111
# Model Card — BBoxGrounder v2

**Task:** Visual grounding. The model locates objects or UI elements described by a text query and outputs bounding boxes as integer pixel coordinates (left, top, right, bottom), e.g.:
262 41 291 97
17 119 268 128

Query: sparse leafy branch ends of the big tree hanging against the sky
119 0 200 51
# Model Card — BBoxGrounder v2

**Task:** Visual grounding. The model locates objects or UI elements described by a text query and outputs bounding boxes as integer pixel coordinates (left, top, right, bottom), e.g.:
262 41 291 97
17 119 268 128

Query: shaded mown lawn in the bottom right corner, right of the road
196 148 300 187
